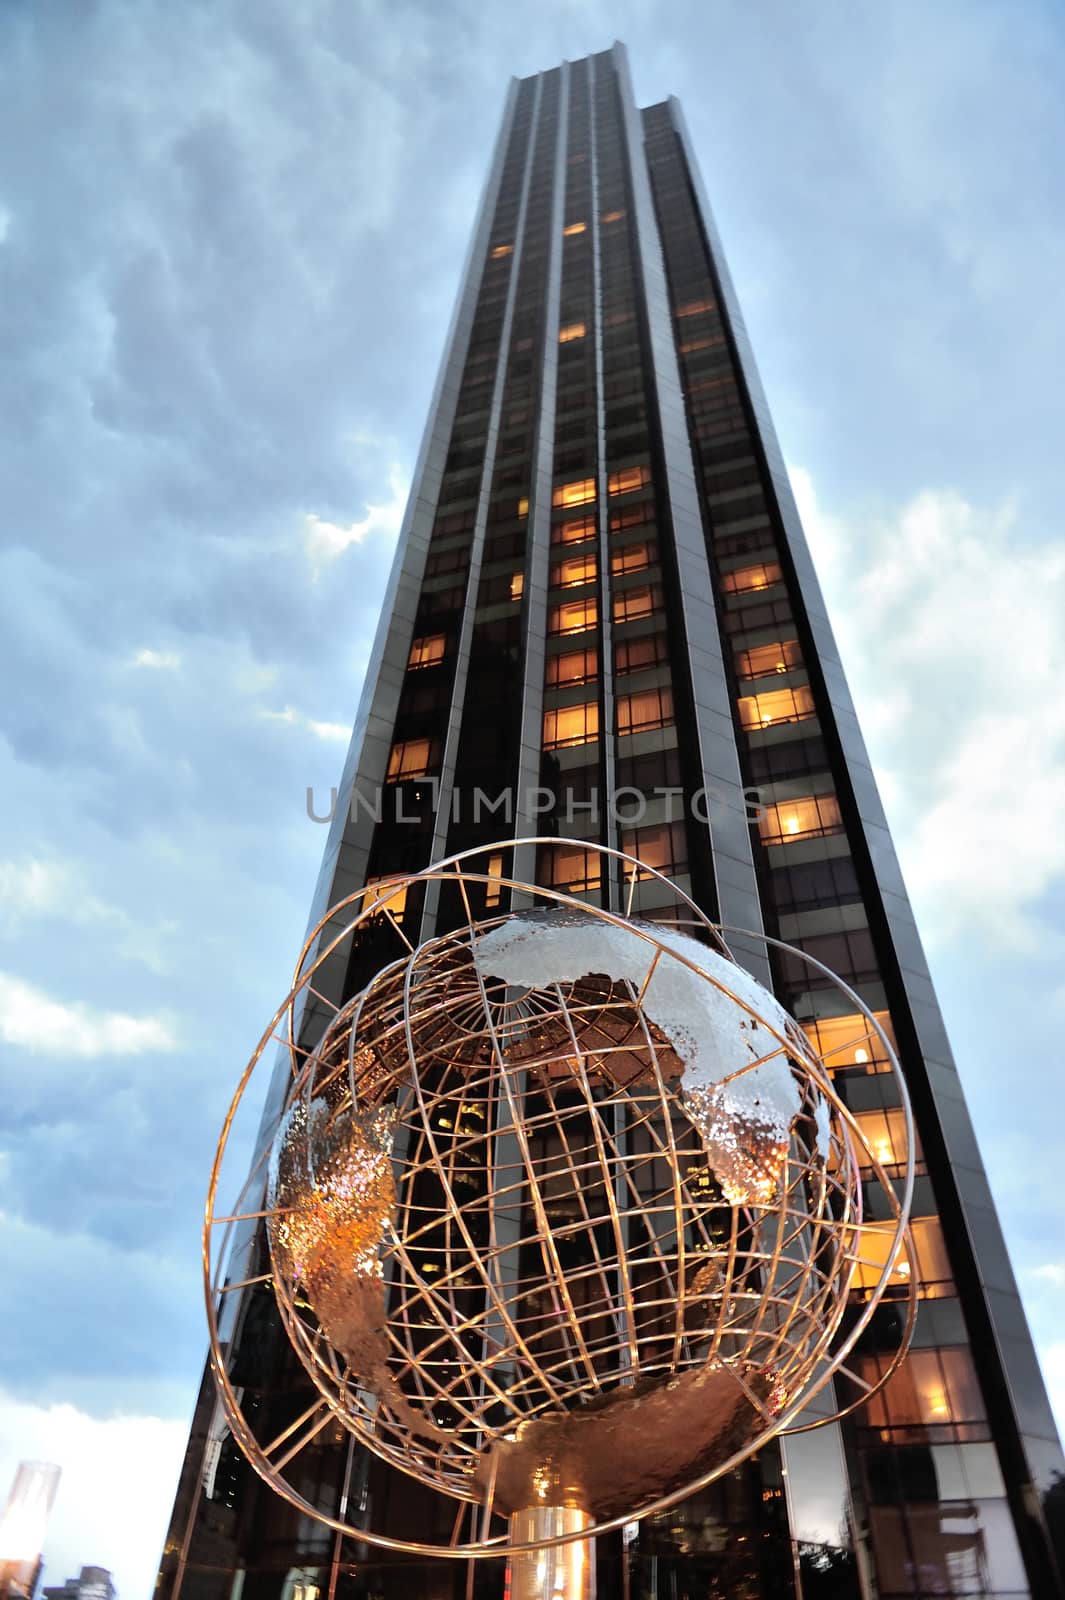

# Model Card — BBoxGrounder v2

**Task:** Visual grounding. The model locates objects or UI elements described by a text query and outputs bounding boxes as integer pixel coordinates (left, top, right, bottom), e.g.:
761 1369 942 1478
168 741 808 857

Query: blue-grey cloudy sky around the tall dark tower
0 0 1065 1600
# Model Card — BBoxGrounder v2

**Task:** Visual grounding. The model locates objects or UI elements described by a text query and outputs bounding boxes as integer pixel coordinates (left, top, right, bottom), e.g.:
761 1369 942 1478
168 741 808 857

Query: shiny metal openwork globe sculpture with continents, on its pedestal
205 846 915 1600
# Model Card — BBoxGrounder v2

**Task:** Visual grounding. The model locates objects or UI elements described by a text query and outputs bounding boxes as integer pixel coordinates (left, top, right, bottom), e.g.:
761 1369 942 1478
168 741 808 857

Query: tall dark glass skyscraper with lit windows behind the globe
158 46 1065 1600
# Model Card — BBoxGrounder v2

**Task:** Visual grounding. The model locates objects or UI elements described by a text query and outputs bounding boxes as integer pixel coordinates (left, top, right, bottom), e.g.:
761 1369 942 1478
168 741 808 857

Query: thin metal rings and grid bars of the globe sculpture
203 837 916 1560
